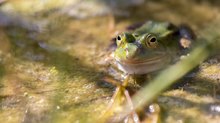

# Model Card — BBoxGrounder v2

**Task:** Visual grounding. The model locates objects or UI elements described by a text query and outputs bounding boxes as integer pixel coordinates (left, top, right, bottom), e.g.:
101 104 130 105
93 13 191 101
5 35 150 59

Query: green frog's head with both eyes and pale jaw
114 32 170 74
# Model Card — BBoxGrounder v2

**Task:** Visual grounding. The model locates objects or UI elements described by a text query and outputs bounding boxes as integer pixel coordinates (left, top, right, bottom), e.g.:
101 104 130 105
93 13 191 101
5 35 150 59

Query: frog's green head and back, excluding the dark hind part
114 21 187 74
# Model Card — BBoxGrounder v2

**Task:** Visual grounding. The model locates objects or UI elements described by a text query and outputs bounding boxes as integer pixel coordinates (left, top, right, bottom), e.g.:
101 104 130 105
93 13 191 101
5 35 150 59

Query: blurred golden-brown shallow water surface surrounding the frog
0 0 220 123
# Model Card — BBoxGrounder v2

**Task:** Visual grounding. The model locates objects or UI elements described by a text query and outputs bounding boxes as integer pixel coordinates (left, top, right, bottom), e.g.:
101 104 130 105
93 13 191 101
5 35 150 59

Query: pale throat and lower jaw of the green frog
116 55 171 74
